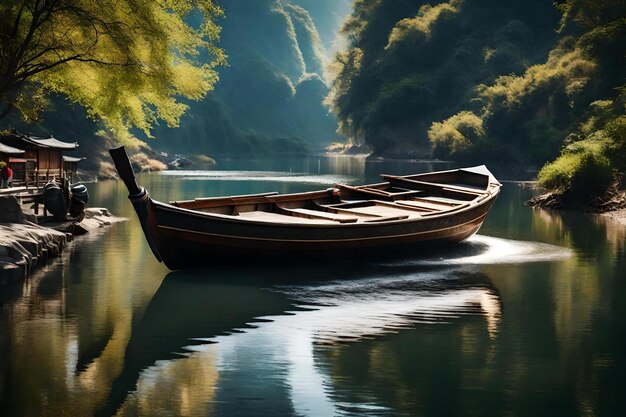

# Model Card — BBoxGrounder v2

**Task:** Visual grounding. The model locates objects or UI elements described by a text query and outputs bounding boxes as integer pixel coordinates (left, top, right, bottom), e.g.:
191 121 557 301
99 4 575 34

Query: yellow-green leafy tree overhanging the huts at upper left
0 0 225 140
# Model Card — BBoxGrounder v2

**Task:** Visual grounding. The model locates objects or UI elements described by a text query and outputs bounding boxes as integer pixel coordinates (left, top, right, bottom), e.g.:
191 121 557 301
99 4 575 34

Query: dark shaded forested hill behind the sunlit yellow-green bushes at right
328 0 558 157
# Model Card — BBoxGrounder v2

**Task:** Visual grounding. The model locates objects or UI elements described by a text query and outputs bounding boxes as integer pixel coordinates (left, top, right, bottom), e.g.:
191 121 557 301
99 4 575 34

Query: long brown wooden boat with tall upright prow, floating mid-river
109 147 501 269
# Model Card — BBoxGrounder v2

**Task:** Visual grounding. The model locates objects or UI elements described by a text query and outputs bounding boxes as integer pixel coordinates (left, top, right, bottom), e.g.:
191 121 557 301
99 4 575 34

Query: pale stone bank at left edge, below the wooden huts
0 195 121 284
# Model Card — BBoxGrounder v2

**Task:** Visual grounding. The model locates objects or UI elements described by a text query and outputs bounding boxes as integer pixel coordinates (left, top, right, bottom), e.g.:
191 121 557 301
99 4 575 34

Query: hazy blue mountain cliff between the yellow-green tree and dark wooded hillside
151 0 349 156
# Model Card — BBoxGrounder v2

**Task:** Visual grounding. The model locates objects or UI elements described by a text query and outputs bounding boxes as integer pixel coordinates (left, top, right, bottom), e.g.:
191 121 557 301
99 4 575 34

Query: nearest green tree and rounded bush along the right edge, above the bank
528 0 626 202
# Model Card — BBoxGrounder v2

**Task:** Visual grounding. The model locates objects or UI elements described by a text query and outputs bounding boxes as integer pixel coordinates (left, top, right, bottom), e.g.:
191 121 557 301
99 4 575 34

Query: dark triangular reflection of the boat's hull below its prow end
100 268 298 415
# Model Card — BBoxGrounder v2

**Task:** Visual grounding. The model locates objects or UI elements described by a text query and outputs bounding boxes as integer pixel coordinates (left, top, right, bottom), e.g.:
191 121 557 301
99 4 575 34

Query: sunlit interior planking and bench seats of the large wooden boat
170 175 488 224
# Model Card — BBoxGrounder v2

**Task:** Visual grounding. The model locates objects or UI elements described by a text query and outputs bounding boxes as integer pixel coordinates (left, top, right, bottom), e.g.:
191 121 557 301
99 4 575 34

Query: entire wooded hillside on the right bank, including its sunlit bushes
330 0 626 205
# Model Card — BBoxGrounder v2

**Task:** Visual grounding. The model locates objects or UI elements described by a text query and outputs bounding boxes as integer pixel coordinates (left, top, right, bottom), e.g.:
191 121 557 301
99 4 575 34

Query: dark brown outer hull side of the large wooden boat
136 193 494 269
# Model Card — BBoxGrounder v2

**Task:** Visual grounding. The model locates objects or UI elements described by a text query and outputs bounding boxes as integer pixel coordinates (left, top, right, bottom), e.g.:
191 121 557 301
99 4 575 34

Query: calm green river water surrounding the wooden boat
0 158 626 416
